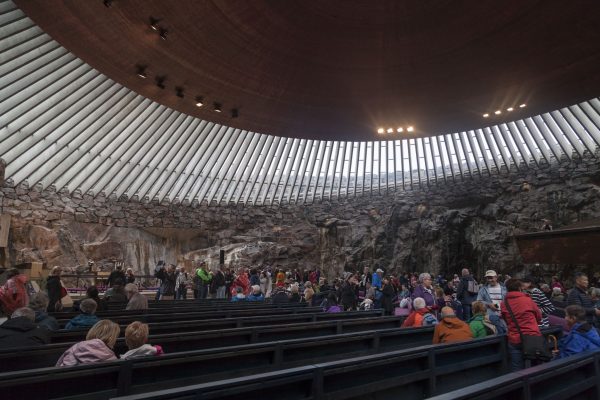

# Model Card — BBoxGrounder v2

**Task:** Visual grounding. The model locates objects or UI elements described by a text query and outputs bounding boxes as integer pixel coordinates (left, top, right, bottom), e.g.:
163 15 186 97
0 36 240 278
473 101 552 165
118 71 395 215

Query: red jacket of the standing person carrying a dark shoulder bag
500 292 542 345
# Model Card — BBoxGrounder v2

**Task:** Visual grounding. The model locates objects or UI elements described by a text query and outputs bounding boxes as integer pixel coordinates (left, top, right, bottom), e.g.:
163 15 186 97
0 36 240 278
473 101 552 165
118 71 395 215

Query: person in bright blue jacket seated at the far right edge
558 305 600 358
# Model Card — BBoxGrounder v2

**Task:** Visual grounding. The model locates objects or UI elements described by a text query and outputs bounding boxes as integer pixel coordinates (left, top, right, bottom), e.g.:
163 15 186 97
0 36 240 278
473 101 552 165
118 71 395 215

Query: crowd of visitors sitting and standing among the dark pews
0 262 600 370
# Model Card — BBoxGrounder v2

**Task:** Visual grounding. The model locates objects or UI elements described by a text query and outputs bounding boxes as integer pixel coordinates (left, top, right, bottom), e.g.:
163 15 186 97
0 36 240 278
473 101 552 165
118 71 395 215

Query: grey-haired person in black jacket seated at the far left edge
0 307 50 349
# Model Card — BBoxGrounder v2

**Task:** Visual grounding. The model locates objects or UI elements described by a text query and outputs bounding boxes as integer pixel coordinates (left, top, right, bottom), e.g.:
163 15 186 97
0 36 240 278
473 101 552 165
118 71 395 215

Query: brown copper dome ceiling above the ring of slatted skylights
10 0 600 140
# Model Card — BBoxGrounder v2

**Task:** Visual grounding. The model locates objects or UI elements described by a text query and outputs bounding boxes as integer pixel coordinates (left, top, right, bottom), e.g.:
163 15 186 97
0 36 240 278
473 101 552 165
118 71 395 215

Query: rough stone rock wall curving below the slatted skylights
0 155 600 276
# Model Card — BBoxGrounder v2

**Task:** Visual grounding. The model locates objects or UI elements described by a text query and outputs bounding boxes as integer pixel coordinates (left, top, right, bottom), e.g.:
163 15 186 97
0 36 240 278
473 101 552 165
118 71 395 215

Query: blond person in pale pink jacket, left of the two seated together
56 319 121 367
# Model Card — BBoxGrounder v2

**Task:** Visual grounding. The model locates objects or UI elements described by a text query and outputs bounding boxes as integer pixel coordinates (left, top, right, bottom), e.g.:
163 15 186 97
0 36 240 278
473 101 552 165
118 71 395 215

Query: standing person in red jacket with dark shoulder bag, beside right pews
501 279 542 371
